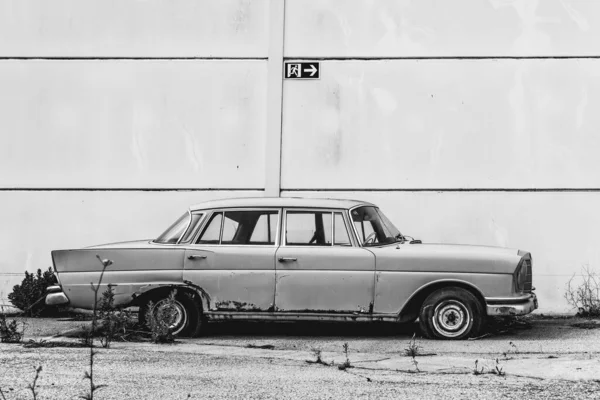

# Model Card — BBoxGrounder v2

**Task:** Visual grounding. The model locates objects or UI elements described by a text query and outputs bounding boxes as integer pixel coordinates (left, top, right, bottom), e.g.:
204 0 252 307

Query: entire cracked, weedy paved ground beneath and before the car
0 318 600 399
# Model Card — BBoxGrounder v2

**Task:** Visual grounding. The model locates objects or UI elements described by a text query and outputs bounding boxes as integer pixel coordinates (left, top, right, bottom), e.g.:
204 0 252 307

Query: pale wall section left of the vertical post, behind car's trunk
0 0 269 304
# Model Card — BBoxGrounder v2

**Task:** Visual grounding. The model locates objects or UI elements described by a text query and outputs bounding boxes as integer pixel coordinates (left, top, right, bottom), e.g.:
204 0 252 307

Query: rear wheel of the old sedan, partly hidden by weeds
138 292 204 337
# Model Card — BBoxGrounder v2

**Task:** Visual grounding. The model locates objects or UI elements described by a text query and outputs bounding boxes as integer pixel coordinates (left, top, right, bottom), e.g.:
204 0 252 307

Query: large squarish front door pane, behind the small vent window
285 211 332 246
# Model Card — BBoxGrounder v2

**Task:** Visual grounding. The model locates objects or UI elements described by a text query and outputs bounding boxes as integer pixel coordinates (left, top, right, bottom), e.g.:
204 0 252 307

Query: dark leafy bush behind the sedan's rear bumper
8 267 56 316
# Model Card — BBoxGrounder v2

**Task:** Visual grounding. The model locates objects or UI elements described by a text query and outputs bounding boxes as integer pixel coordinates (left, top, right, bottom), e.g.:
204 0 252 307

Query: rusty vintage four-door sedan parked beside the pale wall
46 198 537 339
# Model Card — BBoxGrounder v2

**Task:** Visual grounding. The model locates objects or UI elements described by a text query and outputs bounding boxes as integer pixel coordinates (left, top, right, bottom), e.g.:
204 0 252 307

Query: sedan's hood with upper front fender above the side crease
367 243 523 274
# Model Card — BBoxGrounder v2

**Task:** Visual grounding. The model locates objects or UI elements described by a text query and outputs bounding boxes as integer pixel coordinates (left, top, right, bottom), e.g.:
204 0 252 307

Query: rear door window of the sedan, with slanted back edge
196 210 279 245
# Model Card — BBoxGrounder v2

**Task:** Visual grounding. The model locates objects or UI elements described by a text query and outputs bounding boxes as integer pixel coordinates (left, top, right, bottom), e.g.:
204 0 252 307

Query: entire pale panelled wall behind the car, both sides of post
0 0 600 312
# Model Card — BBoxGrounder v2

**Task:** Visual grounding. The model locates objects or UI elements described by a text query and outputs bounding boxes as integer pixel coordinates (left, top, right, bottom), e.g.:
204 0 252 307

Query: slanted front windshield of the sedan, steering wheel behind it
351 206 402 246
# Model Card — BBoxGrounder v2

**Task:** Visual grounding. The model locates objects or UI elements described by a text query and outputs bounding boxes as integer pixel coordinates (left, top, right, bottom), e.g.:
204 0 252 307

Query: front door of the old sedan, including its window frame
275 209 375 314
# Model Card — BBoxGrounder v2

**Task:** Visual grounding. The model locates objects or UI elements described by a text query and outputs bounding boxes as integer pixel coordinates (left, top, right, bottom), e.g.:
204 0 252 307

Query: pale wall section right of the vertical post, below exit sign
281 0 600 312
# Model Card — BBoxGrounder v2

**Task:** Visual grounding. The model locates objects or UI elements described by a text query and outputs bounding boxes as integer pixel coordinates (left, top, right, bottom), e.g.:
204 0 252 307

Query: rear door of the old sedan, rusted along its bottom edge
183 209 280 313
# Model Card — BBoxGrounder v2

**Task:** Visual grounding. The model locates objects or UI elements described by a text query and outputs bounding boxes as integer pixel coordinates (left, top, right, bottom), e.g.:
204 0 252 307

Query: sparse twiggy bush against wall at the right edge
565 265 600 318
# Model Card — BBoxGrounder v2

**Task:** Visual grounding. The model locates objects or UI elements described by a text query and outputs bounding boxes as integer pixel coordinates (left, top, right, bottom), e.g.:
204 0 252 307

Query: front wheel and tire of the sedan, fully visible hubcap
419 287 485 340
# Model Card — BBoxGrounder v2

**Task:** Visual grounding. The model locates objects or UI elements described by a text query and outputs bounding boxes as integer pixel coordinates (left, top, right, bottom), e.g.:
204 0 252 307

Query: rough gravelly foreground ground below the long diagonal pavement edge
0 345 600 399
